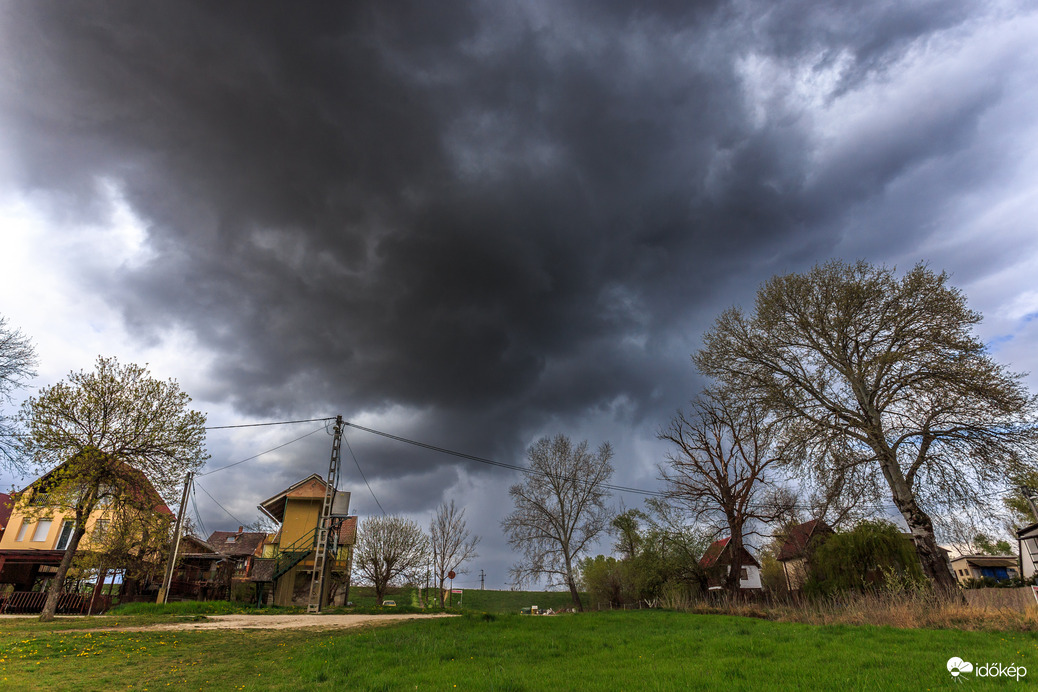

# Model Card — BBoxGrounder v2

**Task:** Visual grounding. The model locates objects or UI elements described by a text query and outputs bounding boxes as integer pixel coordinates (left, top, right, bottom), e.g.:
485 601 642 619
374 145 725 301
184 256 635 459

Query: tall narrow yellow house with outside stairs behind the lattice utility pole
260 473 357 606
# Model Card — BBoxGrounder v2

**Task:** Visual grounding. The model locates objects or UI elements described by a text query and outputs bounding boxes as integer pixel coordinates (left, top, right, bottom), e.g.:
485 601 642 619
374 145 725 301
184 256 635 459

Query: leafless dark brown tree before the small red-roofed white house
659 390 794 594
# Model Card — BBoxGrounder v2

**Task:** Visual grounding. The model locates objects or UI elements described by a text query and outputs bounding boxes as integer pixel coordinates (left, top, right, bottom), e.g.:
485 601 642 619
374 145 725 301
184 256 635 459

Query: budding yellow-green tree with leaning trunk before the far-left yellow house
19 358 208 620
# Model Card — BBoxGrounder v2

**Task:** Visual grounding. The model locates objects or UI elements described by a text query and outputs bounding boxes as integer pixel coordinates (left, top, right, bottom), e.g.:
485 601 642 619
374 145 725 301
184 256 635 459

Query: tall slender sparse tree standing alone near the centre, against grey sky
501 435 612 610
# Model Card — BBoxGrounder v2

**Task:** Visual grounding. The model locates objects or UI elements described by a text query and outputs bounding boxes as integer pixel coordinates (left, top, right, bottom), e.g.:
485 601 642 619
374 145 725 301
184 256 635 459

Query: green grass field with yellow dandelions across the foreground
0 604 1038 691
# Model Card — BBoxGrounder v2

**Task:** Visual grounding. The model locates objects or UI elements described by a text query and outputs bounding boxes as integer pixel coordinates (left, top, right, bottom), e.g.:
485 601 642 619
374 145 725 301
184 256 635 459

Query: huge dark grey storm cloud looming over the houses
0 2 1021 500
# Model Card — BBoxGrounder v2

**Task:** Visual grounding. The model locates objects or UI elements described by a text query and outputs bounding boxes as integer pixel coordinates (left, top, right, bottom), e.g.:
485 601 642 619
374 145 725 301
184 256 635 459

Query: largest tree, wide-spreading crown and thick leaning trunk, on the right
693 261 1038 589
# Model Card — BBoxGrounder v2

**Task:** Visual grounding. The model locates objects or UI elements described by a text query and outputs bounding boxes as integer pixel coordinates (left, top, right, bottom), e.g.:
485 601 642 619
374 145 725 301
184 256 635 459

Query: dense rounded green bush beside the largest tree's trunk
803 521 925 593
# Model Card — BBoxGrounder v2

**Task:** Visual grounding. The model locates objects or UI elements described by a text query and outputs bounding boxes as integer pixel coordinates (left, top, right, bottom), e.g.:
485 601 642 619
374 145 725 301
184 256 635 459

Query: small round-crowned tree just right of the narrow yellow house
354 517 429 606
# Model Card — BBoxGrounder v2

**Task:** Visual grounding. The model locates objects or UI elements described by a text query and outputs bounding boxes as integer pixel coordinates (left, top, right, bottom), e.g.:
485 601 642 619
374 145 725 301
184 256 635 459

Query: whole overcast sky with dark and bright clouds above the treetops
0 0 1038 586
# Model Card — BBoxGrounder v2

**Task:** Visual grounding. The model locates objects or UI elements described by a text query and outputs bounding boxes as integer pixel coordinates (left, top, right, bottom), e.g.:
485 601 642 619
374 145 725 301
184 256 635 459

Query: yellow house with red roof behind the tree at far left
0 464 173 591
